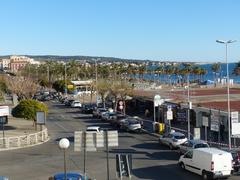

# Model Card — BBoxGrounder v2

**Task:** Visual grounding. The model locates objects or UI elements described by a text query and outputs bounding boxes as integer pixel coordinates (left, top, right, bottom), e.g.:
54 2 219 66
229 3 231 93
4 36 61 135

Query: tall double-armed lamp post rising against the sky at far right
216 40 236 149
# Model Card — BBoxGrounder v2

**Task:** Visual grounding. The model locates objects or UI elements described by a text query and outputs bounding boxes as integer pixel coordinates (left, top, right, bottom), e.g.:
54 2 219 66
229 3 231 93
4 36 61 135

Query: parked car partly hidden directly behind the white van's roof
178 139 209 155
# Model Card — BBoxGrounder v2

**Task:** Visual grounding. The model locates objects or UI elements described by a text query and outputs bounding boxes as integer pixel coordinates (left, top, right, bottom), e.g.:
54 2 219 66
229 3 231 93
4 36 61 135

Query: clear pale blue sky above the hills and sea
0 0 240 62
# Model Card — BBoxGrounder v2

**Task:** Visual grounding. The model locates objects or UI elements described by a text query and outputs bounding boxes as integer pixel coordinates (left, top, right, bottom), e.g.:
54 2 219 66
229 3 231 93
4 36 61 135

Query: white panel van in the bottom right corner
179 148 232 179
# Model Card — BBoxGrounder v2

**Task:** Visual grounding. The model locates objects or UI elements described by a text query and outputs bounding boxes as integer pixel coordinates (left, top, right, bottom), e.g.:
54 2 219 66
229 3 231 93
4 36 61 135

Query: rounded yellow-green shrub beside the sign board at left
12 99 48 120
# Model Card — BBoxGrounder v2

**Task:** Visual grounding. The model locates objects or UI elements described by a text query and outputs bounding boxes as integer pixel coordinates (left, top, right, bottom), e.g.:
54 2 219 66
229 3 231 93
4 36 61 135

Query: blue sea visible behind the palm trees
144 63 240 84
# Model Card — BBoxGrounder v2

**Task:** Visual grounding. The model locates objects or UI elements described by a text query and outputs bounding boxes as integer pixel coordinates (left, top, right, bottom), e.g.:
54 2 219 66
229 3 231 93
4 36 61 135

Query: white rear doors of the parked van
212 153 232 176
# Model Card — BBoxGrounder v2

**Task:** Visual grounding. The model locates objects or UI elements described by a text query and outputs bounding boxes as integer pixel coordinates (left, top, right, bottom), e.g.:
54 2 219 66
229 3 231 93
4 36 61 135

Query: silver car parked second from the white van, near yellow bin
159 130 187 149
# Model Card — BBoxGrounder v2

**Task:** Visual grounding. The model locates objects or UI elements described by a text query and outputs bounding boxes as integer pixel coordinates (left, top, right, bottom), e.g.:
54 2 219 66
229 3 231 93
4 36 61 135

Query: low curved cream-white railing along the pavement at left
0 128 49 151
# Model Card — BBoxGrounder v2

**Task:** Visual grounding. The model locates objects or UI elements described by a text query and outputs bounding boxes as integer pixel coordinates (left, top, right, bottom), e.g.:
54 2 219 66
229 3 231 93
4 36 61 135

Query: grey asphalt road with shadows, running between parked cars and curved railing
0 102 239 180
